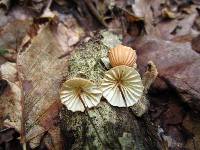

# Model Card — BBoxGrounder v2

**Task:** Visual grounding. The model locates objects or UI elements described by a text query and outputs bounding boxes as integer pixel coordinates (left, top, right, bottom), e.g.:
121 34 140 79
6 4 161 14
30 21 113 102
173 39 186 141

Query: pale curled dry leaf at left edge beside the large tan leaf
0 59 22 132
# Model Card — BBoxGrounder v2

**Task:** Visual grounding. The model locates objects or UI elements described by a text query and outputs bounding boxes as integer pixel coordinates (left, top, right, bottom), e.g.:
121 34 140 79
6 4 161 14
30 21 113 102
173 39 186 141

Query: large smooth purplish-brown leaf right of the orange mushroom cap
134 36 200 112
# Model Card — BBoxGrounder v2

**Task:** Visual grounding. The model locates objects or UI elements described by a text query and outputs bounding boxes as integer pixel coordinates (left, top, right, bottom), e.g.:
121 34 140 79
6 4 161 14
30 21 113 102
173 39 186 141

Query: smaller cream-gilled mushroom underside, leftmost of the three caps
60 78 102 112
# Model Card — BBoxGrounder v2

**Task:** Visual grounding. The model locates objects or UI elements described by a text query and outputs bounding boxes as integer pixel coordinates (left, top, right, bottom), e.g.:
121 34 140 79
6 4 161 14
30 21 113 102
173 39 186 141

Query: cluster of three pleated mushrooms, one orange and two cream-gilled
60 45 144 112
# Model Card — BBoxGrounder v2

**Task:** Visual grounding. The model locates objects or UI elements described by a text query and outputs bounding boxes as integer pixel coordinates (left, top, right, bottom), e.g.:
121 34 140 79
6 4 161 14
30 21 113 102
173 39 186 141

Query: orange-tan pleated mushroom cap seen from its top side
108 45 137 67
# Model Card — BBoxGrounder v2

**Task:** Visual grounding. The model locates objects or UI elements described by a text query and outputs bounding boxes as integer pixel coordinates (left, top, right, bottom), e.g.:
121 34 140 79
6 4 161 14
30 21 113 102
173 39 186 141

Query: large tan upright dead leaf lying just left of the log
14 25 67 149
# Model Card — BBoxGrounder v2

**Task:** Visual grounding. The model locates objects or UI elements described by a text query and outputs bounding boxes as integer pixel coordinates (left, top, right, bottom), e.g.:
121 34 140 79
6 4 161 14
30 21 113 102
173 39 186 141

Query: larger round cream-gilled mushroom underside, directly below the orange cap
102 65 144 107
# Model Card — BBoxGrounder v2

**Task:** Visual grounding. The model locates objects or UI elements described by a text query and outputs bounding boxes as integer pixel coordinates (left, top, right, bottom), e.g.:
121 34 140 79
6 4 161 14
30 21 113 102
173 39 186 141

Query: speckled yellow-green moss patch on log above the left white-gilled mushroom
68 41 108 84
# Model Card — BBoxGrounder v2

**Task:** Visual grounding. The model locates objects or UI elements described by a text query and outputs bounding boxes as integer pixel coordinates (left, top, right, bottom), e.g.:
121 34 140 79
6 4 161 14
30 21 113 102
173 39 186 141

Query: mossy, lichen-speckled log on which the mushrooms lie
61 32 160 150
